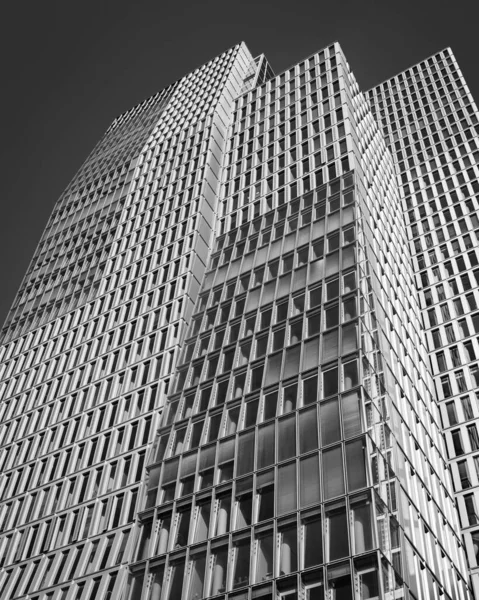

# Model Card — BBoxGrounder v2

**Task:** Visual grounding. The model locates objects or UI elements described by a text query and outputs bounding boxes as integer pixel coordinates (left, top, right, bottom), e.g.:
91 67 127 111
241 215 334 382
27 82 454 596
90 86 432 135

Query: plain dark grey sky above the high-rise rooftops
0 0 479 326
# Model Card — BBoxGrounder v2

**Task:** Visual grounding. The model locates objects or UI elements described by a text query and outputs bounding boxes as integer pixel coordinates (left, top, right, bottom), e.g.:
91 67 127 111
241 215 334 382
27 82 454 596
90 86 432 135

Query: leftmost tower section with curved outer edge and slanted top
0 44 255 600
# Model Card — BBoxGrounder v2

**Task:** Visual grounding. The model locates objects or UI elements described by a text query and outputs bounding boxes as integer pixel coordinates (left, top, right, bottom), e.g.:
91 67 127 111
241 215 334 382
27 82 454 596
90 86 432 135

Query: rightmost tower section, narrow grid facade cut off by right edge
368 49 479 596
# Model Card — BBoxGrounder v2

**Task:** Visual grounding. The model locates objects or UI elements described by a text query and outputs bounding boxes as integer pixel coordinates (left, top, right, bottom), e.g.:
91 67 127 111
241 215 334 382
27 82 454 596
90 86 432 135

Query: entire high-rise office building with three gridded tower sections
0 39 479 600
